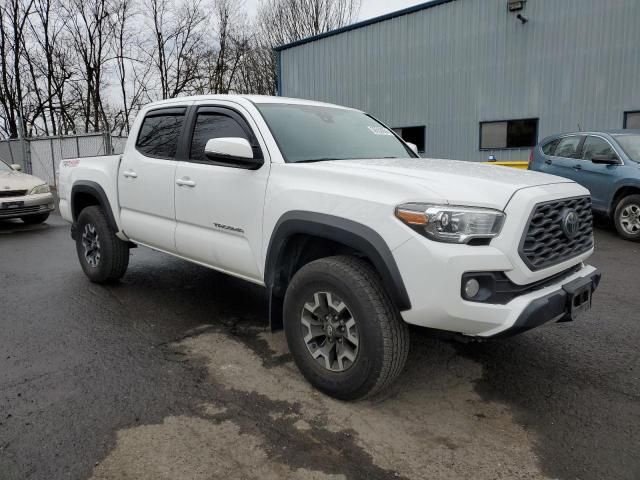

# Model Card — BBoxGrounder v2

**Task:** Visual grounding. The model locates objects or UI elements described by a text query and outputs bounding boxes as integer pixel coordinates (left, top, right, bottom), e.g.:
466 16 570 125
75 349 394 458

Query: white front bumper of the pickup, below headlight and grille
393 237 600 338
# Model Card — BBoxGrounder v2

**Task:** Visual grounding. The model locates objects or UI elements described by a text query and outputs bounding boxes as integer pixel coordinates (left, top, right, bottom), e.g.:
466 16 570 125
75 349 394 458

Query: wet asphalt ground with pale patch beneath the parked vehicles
0 216 640 480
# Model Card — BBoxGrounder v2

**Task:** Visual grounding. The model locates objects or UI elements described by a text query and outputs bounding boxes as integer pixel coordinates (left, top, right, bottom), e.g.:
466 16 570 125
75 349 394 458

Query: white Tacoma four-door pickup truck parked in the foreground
59 96 600 399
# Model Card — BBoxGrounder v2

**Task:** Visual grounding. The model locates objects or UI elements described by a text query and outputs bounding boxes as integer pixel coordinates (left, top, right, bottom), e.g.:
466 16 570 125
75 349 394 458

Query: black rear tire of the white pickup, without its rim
76 206 129 283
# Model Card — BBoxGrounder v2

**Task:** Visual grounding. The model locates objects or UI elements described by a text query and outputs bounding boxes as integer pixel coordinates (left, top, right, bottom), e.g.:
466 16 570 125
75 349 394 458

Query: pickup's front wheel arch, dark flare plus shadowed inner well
264 211 411 330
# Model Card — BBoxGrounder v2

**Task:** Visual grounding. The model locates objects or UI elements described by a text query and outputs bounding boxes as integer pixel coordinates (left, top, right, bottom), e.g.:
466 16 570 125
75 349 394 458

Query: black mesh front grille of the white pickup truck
519 197 593 271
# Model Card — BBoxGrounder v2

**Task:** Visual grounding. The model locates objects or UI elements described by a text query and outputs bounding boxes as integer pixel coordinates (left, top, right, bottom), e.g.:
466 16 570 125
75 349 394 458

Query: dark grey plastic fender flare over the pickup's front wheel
264 210 411 311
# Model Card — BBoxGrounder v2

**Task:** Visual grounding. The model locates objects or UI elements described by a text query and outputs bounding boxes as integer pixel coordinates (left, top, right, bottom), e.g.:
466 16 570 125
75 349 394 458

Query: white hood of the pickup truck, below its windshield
316 158 574 209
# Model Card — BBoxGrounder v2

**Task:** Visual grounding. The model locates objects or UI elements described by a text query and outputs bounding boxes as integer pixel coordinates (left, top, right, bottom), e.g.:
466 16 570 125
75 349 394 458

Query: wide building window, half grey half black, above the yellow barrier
480 118 538 150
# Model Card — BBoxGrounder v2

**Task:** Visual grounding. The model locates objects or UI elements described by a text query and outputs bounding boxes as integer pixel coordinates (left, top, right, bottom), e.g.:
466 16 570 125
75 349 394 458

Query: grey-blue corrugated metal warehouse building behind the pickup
276 0 640 160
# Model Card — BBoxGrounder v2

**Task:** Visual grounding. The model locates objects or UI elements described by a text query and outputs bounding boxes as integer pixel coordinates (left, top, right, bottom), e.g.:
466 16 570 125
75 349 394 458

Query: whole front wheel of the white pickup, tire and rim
284 256 409 400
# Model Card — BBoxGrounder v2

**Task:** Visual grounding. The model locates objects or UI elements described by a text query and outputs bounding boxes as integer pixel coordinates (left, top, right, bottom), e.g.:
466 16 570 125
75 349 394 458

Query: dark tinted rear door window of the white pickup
136 111 184 158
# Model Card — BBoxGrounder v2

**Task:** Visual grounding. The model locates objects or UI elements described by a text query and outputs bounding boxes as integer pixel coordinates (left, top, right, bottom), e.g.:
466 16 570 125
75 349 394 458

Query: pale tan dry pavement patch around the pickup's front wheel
94 331 545 480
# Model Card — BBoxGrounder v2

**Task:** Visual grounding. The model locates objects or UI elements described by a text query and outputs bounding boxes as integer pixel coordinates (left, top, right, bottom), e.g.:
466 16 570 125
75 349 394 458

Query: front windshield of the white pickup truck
257 103 417 163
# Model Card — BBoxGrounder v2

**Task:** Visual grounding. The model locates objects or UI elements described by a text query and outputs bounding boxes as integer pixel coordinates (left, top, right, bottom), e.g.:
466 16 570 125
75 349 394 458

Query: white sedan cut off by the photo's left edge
0 160 55 224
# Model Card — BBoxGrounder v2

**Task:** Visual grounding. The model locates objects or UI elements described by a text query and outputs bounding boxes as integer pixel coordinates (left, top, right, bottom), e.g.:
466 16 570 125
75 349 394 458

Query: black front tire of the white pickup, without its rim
284 256 409 400
